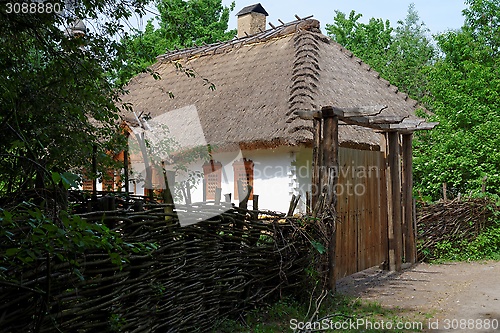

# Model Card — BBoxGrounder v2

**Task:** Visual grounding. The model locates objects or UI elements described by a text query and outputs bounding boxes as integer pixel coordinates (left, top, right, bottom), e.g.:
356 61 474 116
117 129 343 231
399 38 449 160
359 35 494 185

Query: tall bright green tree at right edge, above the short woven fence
415 0 500 199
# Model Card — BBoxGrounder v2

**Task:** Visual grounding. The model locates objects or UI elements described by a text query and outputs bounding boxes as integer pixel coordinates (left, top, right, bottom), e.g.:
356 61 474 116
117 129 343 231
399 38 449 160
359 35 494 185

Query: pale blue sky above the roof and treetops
222 0 466 34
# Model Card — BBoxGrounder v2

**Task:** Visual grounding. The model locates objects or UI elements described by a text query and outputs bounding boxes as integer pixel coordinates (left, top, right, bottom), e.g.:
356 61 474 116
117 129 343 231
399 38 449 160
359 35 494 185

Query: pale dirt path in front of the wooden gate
338 261 500 332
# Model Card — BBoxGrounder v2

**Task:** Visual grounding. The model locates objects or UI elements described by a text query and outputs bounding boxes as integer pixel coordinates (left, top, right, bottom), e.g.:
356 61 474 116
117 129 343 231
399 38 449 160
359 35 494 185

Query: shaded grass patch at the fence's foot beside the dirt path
213 295 431 333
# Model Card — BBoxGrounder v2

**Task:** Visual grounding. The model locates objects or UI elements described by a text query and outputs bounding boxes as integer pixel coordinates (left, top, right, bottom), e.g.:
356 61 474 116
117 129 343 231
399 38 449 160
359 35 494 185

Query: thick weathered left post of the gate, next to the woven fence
320 108 339 292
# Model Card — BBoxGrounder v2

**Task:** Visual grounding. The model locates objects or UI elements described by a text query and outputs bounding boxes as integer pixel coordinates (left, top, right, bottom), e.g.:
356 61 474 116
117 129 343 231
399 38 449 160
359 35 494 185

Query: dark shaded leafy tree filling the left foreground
0 0 156 326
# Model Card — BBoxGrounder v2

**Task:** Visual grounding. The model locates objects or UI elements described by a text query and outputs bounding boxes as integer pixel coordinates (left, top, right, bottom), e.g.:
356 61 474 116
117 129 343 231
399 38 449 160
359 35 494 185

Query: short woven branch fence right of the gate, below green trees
417 198 500 261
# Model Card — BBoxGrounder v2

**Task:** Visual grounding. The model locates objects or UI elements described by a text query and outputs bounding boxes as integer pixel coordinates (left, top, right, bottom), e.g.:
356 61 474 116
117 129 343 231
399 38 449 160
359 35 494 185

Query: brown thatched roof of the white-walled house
123 19 417 148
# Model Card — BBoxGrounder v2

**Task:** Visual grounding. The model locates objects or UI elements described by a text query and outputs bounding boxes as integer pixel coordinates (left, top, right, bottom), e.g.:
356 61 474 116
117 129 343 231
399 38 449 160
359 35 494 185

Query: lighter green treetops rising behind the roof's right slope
326 4 435 98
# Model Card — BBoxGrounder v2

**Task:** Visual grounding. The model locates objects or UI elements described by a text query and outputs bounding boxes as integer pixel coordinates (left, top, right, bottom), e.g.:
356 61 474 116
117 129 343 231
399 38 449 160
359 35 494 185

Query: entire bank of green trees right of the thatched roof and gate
326 0 500 200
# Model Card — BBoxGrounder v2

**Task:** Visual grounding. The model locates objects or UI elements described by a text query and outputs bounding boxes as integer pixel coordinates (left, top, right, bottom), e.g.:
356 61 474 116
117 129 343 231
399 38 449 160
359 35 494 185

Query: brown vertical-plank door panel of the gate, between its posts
335 147 388 279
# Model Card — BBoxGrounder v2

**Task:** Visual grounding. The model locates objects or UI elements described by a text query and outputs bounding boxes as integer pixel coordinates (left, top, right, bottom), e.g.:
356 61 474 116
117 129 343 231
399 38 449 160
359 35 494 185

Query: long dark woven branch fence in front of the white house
0 200 311 333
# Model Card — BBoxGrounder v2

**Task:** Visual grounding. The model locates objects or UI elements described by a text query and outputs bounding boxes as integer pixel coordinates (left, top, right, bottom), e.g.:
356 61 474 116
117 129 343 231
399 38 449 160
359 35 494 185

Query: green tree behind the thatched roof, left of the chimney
118 0 236 84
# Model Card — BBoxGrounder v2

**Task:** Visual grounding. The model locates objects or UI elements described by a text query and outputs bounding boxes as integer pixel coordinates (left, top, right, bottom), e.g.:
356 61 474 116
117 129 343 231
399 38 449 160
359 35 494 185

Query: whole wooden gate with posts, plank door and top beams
295 106 437 290
